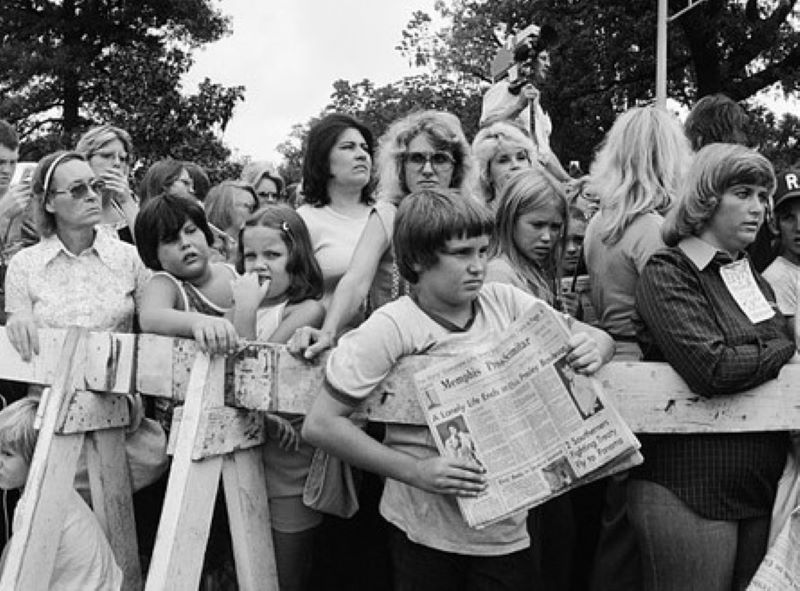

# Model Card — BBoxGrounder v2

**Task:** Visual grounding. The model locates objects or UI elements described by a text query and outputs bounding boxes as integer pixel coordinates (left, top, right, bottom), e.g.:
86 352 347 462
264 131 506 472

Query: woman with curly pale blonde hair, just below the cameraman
472 121 538 209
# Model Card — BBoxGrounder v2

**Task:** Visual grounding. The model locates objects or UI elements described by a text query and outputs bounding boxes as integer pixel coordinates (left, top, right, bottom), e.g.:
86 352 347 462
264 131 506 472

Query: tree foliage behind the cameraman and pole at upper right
284 0 800 176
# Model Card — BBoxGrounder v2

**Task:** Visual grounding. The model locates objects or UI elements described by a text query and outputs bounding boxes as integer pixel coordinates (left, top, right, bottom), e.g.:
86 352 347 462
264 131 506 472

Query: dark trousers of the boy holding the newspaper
389 526 537 591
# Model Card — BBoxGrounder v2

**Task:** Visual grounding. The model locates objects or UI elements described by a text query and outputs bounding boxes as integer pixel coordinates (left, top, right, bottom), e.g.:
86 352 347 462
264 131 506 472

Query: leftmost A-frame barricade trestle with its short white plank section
0 328 142 591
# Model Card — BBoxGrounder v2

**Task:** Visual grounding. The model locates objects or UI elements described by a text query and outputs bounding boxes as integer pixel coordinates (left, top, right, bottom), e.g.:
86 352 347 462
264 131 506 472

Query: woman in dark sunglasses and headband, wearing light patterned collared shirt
6 152 166 494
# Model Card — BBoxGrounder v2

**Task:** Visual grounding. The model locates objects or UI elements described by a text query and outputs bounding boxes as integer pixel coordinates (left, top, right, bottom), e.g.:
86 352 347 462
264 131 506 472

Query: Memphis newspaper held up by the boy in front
414 302 642 528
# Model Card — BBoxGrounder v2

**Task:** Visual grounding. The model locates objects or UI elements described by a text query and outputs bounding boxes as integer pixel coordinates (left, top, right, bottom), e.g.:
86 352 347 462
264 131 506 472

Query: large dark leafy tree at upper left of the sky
0 0 244 178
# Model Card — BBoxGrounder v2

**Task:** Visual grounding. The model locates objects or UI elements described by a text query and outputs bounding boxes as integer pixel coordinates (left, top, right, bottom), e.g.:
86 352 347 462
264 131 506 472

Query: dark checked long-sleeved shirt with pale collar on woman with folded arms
633 237 794 520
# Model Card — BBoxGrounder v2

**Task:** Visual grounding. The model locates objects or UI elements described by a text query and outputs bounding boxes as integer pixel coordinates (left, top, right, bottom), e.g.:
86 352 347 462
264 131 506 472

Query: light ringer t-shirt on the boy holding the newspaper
326 283 539 556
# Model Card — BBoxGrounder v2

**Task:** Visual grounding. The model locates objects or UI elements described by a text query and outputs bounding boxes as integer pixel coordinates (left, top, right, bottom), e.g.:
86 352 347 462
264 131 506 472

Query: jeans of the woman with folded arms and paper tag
628 479 770 591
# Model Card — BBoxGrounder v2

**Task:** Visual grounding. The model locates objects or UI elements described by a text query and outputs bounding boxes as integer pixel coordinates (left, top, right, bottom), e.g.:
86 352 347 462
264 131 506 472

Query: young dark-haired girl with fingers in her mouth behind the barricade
233 204 325 590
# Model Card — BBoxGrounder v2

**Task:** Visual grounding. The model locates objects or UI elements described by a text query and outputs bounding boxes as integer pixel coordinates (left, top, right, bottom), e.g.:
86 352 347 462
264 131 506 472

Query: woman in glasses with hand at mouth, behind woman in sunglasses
75 125 139 243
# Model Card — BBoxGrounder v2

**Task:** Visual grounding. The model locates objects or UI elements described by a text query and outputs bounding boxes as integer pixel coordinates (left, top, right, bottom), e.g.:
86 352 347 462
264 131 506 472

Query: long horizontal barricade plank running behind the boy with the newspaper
142 342 800 433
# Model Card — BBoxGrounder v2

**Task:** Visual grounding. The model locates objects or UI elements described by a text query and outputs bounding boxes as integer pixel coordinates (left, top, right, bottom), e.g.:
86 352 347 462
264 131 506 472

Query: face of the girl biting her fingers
242 226 291 301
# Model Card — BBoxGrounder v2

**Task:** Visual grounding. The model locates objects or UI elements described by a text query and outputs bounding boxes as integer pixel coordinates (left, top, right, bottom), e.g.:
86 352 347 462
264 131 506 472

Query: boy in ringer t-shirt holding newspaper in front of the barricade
303 190 613 591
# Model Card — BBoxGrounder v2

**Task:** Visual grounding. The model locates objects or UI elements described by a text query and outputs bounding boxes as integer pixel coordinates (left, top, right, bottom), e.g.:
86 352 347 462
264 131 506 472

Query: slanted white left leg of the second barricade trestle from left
145 355 225 591
